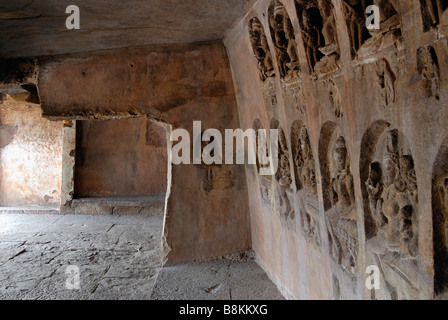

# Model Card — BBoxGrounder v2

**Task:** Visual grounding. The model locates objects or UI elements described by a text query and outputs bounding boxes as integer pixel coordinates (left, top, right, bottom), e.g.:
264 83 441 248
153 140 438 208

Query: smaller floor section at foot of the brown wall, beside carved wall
151 258 283 300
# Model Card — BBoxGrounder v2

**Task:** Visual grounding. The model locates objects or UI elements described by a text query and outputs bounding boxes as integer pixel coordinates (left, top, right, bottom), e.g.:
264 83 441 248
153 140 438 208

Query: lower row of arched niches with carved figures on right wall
253 119 448 298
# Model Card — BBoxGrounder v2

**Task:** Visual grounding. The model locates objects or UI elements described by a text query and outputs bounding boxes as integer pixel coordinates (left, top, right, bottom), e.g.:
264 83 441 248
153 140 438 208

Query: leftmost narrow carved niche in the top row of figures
249 18 275 81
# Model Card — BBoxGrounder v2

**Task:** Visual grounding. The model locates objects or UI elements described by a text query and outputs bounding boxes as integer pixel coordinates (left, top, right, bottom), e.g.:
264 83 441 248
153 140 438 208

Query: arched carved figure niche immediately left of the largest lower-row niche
319 122 358 281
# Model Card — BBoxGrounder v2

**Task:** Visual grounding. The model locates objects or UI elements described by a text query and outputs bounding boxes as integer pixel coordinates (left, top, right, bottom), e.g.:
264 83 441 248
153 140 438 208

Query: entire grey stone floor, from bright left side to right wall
0 213 282 300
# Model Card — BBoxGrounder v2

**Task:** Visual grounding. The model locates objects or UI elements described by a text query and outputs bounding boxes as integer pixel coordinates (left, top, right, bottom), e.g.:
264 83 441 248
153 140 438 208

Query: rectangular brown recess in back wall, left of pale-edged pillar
75 118 167 199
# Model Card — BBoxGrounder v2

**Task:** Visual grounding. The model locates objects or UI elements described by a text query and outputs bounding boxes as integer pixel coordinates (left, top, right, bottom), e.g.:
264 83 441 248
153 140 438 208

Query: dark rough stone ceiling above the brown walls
0 0 255 57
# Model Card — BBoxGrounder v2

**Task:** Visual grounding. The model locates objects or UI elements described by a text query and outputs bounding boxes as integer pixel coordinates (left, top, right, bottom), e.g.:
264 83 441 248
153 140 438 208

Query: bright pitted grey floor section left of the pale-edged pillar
0 214 163 300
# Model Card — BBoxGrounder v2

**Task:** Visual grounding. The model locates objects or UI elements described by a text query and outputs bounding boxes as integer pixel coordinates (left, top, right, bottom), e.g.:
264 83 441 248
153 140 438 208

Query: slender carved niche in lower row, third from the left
291 121 321 246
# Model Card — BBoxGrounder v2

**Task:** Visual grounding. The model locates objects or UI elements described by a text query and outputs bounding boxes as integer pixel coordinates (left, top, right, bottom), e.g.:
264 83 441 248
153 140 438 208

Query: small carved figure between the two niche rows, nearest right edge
417 46 440 100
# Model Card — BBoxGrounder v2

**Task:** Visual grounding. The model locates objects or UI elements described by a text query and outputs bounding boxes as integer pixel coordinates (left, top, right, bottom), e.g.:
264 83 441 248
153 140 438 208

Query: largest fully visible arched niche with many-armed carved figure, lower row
365 129 418 299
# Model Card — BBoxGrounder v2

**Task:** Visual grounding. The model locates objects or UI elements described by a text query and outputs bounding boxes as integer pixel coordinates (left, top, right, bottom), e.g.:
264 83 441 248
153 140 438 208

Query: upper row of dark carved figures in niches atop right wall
249 0 448 82
